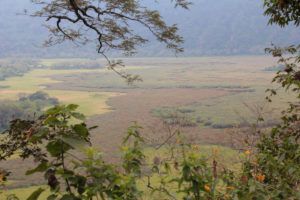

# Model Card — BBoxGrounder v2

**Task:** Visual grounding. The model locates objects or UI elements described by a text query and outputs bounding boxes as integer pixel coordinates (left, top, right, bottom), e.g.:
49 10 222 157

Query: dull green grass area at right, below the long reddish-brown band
152 87 296 128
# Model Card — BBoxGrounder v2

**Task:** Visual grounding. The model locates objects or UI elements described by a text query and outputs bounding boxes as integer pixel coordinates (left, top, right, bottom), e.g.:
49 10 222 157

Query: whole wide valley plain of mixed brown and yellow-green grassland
0 56 293 199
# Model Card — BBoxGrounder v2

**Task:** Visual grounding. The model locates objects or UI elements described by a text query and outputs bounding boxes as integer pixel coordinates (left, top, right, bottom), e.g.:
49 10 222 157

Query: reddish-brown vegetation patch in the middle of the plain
90 88 228 159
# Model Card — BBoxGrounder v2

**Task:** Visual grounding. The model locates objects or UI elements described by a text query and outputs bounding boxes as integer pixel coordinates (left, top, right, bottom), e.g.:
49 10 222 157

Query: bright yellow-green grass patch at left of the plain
0 69 120 116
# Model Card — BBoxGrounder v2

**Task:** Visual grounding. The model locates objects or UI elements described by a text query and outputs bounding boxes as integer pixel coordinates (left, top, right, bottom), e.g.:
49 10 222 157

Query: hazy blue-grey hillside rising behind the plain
0 0 300 57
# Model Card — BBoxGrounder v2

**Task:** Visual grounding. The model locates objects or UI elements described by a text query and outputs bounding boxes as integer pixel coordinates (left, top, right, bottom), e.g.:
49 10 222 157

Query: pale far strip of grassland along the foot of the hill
47 56 276 89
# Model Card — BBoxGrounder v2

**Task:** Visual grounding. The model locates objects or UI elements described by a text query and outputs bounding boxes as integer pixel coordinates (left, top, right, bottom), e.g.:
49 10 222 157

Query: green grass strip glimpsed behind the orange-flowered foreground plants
139 144 245 200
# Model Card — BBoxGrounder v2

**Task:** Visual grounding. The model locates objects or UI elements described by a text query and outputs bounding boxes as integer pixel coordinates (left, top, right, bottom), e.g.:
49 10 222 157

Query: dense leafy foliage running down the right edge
238 0 300 199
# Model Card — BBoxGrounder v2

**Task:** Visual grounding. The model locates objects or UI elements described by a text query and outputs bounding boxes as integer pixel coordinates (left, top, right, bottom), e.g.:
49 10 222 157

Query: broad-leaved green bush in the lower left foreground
0 104 144 200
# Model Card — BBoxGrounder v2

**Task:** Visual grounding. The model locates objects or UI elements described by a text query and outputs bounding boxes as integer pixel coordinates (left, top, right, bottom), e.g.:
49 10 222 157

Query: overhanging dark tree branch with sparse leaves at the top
26 0 191 83
